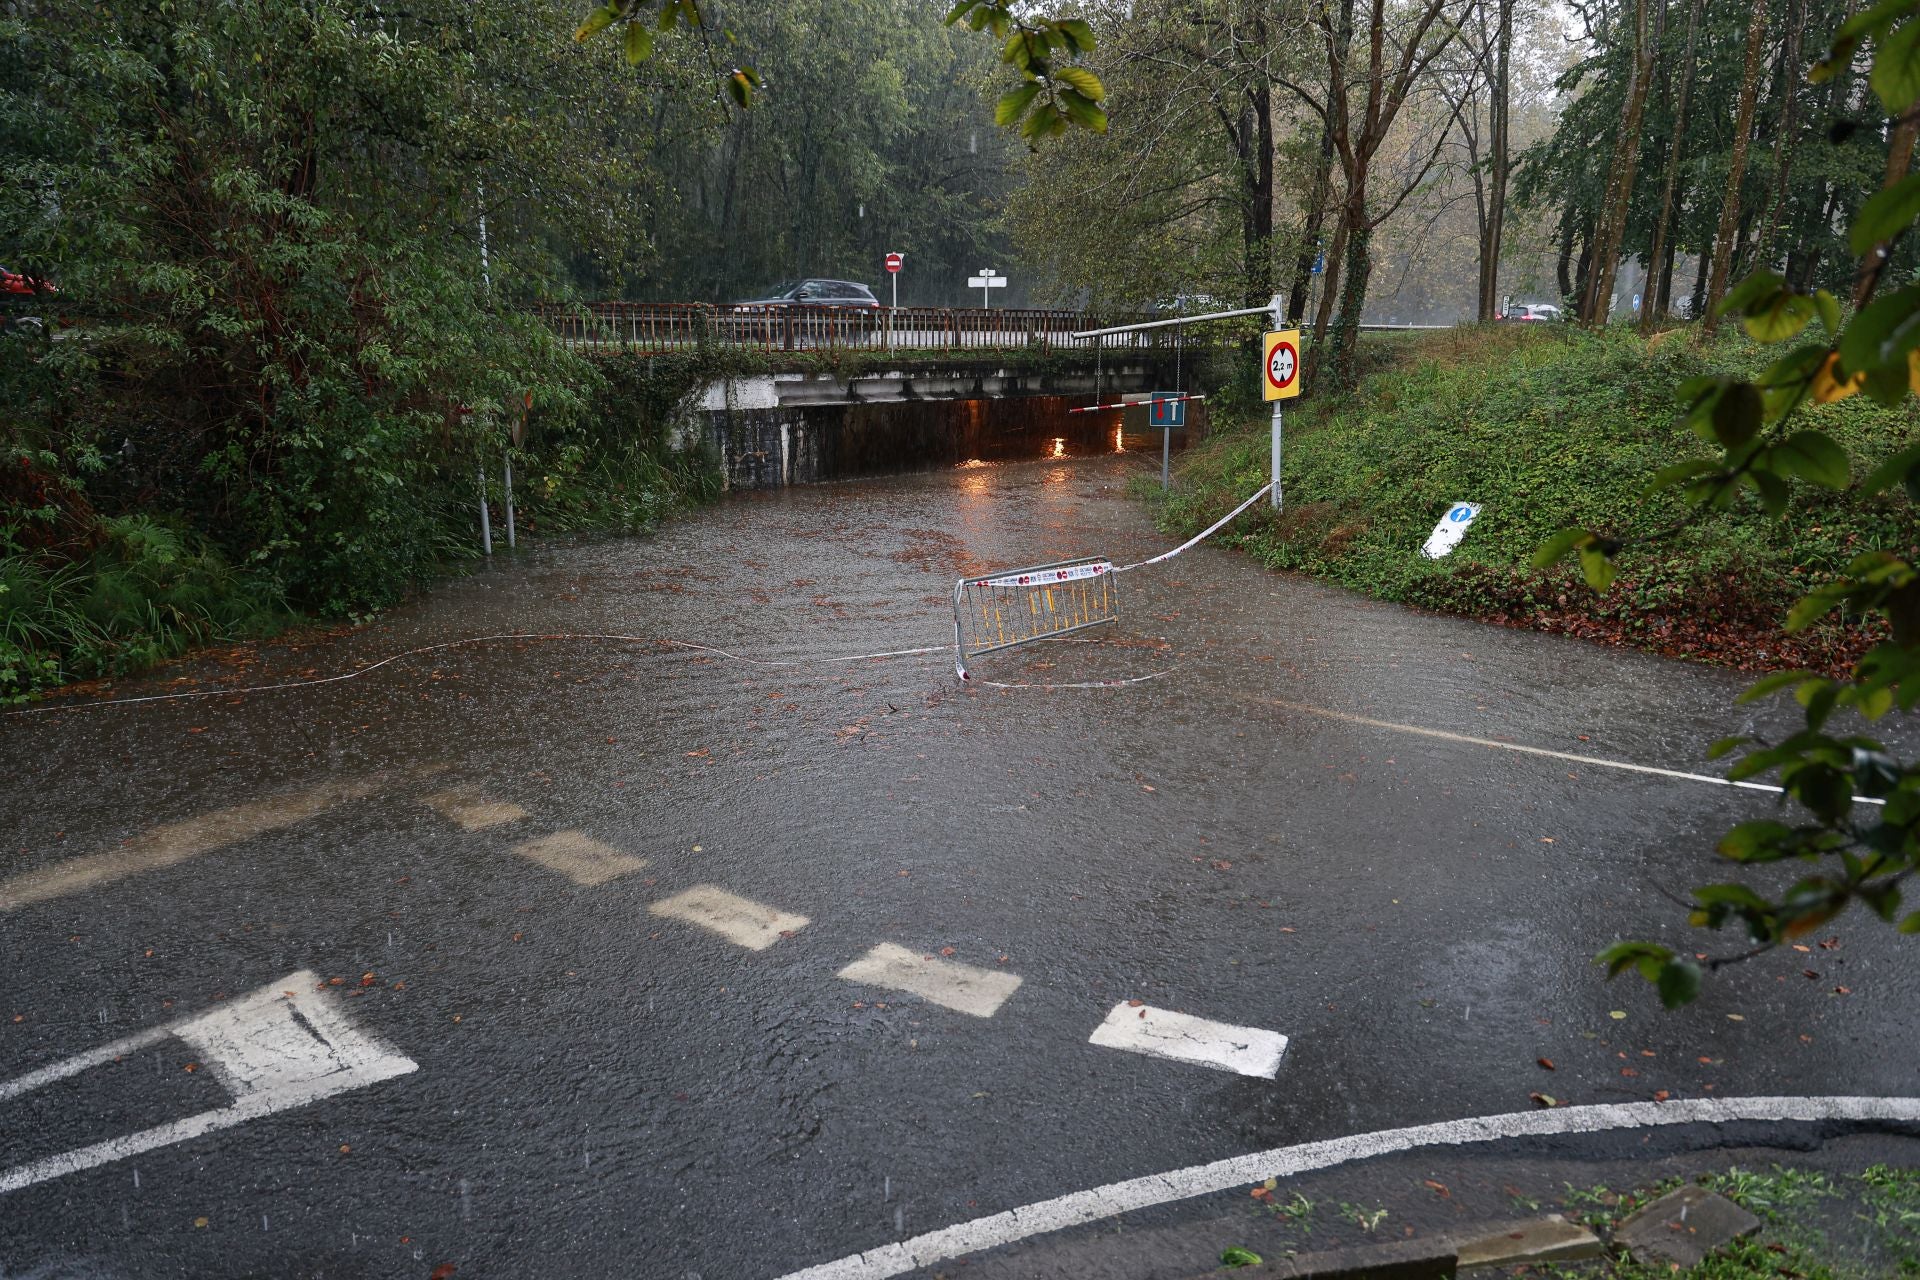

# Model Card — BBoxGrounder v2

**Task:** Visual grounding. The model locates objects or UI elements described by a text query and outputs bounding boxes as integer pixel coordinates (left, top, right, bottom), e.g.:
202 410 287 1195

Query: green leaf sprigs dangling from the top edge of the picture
574 0 1106 142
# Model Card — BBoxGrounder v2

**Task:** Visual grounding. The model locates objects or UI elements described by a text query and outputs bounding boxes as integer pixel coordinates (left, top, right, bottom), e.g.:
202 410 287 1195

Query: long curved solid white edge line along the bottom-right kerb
781 1098 1920 1280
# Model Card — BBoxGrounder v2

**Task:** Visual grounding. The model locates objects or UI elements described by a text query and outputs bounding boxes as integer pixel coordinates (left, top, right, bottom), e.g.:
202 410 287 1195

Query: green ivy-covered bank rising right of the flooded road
1162 324 1920 672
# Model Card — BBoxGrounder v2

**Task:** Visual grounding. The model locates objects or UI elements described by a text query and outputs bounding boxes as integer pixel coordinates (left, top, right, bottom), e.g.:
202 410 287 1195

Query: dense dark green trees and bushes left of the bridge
0 0 718 695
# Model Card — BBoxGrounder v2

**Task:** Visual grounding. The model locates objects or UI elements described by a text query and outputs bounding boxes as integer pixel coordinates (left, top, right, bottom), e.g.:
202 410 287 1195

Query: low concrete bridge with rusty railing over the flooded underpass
541 303 1236 487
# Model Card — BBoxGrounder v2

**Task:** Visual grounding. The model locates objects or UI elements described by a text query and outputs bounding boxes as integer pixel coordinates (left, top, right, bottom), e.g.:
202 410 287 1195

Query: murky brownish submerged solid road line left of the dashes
0 779 380 912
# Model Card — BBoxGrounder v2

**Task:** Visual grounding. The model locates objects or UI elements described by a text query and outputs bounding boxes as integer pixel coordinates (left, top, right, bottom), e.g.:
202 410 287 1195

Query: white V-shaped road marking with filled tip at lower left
0 969 417 1196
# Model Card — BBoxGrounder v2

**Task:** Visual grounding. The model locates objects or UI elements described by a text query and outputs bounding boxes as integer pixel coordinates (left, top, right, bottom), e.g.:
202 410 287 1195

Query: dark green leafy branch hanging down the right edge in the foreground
1534 0 1920 1007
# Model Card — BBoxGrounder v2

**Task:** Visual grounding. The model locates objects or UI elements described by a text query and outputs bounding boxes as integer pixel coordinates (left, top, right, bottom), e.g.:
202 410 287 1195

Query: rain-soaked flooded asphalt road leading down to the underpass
0 445 1920 1280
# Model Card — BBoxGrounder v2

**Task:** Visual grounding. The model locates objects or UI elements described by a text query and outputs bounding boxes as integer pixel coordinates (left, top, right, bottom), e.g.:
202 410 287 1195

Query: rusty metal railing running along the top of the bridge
536 301 1246 355
